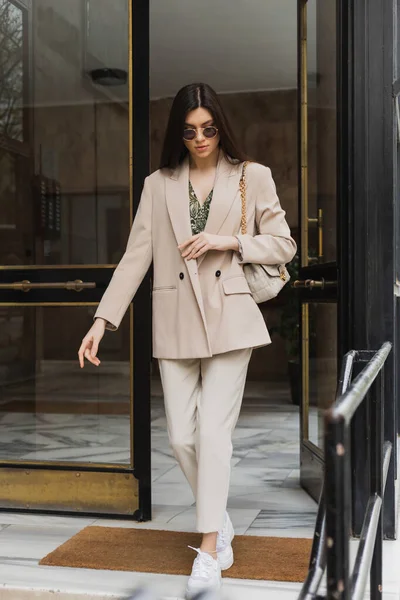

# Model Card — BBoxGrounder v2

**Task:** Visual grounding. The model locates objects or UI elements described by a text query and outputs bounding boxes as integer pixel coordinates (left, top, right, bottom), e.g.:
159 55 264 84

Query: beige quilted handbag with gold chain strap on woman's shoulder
239 162 290 304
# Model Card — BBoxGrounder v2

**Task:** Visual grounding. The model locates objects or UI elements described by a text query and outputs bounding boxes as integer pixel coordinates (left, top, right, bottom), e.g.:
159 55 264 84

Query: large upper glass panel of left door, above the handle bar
0 0 130 265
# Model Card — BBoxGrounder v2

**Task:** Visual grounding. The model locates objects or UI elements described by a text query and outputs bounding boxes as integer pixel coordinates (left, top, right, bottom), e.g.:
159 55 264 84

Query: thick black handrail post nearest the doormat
325 410 351 600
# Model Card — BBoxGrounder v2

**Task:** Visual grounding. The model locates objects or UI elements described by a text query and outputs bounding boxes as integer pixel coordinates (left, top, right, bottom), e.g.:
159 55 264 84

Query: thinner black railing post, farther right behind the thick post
370 366 385 600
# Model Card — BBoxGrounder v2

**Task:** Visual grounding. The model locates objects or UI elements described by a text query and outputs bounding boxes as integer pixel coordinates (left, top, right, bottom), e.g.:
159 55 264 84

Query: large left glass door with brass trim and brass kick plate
0 0 149 515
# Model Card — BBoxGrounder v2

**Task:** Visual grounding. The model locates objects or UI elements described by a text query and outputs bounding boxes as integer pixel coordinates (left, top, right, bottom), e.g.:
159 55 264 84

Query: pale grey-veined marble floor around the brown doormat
0 372 400 600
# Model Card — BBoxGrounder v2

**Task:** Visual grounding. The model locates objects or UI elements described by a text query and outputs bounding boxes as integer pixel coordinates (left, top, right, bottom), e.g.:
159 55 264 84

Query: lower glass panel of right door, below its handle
308 303 338 450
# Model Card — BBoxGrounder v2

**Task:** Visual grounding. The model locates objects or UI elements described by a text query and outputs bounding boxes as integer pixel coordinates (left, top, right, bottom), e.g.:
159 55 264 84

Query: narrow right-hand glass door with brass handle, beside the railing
294 0 338 499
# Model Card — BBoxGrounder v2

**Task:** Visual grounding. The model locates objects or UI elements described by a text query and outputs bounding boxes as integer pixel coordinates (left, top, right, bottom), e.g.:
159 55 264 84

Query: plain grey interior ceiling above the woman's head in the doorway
150 0 316 98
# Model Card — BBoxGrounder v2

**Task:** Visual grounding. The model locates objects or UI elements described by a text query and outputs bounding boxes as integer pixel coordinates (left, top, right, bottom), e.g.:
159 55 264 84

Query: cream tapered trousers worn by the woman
159 348 251 533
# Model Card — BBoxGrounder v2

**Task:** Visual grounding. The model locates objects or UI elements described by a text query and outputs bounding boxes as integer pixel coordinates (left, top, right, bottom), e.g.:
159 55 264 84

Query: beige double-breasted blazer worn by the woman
95 154 296 359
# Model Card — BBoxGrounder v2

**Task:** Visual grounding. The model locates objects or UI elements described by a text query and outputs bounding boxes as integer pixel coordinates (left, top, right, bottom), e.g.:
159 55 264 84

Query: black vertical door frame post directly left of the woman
130 0 152 521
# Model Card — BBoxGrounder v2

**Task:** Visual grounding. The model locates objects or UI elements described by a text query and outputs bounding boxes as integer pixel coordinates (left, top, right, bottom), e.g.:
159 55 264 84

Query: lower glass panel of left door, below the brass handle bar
0 306 131 464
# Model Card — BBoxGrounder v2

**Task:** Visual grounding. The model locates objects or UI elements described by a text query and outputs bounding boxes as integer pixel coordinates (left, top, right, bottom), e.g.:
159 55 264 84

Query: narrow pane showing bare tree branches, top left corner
0 0 24 141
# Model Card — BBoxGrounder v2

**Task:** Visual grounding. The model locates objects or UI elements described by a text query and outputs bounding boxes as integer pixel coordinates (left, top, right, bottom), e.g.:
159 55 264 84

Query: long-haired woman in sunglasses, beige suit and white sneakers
79 84 296 598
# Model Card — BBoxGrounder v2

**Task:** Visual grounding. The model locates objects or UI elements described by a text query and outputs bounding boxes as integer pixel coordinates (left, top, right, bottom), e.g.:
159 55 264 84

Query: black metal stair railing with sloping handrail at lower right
298 342 392 600
